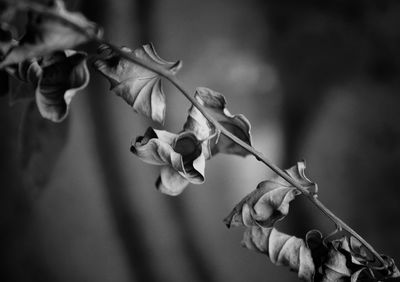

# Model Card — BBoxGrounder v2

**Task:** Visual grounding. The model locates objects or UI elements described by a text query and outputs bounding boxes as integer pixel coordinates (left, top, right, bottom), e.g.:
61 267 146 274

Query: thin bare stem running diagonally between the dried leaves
6 0 388 268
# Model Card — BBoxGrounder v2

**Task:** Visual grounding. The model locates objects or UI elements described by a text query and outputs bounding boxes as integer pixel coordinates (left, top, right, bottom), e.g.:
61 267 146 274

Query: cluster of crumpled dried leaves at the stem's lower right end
225 162 400 281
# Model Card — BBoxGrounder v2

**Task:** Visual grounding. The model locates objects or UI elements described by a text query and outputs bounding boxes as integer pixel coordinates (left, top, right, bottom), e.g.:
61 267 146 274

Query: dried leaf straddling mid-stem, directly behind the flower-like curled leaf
184 87 251 156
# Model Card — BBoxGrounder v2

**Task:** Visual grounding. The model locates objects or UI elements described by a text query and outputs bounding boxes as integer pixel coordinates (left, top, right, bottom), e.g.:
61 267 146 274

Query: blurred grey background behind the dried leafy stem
0 0 400 282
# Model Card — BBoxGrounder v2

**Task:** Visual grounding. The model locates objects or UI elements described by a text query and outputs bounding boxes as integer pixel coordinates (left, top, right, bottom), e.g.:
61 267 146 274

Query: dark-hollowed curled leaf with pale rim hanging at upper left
36 51 89 122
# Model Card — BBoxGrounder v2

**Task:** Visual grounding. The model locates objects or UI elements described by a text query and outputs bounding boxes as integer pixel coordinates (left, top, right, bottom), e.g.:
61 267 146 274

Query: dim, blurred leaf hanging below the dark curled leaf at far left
19 101 69 189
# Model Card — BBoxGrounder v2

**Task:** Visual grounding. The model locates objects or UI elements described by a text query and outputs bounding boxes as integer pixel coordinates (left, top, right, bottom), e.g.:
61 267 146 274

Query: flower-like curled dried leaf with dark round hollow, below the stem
131 128 205 196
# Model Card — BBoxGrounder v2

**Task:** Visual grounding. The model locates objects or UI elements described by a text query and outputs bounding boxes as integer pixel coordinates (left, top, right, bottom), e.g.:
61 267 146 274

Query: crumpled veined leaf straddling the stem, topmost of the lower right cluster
224 162 316 227
